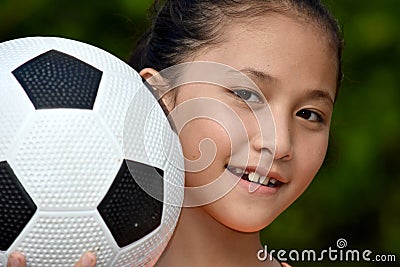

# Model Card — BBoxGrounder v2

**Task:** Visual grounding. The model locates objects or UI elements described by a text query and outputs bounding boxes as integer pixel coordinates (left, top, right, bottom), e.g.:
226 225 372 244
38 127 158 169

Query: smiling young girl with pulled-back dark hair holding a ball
10 0 343 266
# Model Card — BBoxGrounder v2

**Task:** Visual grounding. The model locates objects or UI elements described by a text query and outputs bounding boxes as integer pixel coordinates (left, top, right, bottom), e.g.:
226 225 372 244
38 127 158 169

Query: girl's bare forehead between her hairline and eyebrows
196 14 338 98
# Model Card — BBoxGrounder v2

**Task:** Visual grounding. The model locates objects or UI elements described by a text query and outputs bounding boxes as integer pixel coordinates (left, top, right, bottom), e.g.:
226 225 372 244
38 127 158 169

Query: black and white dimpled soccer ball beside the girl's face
0 37 184 267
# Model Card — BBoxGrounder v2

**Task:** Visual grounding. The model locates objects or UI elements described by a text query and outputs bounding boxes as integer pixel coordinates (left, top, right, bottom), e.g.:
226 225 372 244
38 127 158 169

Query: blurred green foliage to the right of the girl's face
262 0 400 266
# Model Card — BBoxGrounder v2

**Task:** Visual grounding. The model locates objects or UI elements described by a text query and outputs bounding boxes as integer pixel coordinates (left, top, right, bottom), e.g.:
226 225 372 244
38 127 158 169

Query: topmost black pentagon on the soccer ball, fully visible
12 50 103 109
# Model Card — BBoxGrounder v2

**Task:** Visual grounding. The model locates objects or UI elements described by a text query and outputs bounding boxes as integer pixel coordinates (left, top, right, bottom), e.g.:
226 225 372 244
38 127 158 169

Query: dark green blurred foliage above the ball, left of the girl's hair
0 0 152 60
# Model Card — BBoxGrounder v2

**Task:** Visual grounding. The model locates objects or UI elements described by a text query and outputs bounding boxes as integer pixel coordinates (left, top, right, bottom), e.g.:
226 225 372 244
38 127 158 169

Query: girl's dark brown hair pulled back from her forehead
129 0 343 91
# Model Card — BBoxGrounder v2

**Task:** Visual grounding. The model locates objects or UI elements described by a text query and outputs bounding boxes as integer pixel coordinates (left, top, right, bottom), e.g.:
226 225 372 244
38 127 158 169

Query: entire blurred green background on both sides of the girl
0 0 400 267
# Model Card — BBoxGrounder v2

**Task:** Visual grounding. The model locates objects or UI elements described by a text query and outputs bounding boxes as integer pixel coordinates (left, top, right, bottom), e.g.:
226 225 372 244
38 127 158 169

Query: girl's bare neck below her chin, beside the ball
157 207 276 267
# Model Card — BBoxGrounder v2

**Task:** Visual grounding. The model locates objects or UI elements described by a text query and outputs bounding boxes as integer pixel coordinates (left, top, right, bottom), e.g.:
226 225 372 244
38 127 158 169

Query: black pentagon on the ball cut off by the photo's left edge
0 161 37 251
